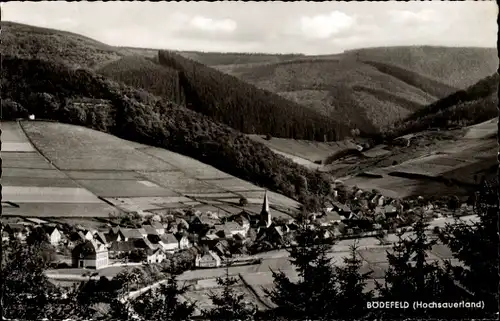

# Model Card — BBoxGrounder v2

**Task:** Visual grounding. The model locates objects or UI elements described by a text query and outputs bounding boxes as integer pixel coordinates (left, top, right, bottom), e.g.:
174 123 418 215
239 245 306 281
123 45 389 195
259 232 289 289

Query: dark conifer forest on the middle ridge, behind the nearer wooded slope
158 51 350 141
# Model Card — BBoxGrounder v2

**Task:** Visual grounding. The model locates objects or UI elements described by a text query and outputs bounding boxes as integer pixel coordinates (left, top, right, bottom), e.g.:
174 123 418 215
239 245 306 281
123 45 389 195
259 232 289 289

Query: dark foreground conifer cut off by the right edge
440 181 499 317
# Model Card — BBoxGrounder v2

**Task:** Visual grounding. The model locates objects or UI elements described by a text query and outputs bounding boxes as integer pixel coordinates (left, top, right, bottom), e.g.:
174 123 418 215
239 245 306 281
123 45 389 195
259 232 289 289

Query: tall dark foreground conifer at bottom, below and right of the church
265 224 338 320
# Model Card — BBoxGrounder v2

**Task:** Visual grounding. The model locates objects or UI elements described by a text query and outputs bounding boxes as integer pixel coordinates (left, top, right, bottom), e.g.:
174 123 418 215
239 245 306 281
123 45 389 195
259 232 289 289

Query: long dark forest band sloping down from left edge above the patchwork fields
1 57 331 207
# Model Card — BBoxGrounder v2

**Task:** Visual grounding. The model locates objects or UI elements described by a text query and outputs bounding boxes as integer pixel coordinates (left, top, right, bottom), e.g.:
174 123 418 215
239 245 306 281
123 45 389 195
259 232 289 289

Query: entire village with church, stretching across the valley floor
2 188 470 276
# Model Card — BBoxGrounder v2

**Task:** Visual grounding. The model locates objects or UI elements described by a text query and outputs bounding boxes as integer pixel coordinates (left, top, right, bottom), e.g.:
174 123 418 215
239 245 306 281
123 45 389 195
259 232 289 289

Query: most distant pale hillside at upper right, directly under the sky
345 46 498 89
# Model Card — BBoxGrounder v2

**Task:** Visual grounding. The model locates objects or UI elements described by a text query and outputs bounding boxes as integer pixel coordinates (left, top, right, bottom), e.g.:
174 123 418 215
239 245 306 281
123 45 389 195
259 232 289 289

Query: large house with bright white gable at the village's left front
71 240 109 269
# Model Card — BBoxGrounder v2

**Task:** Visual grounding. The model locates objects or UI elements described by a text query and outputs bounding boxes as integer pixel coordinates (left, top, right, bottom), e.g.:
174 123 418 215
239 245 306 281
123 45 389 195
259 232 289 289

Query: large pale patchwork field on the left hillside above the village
2 121 298 217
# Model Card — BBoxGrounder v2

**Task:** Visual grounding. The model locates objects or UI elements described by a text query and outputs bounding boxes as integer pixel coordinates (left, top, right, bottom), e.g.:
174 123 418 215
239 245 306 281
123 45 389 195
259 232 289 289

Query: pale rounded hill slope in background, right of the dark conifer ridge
217 55 455 132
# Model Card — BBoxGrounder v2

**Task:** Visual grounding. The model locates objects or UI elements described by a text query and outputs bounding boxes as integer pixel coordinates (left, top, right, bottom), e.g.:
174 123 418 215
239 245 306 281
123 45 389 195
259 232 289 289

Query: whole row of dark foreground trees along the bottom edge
2 182 499 320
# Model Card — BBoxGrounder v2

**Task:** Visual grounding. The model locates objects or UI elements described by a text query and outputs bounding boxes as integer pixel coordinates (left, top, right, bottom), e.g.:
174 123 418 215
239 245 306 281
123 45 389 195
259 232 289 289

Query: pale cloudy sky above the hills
2 1 498 54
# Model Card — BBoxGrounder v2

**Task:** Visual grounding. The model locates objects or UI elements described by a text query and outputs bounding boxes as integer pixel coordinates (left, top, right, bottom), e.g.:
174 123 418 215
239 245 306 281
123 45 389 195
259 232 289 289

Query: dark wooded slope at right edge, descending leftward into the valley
383 73 500 138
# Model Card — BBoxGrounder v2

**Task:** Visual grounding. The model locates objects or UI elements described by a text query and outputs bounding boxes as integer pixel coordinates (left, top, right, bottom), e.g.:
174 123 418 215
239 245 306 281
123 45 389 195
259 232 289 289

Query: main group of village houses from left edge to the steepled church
2 193 300 269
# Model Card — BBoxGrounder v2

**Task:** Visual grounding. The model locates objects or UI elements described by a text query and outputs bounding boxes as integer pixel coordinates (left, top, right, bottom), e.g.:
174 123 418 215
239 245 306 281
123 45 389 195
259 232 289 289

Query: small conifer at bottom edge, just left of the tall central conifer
203 269 257 321
